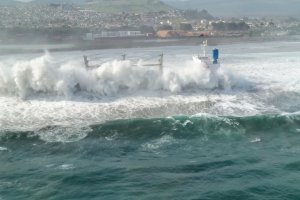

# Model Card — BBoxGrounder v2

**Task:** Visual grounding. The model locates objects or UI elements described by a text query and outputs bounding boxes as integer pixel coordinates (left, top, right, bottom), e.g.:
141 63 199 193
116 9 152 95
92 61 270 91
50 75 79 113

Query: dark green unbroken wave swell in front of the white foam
1 114 300 142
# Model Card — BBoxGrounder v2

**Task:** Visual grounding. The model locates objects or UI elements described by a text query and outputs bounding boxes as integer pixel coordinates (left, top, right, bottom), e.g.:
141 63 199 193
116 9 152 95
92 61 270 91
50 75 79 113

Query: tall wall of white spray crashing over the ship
0 53 251 98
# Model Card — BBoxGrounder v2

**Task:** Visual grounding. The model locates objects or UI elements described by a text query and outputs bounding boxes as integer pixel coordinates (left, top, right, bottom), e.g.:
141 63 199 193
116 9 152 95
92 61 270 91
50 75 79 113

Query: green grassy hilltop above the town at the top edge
86 0 173 13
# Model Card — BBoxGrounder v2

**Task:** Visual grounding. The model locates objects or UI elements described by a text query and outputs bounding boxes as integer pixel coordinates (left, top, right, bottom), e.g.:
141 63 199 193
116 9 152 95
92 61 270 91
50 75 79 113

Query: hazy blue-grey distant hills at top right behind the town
162 0 300 17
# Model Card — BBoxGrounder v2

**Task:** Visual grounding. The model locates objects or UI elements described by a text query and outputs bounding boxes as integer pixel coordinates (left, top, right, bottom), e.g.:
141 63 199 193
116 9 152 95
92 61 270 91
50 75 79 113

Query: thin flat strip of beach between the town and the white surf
0 36 295 56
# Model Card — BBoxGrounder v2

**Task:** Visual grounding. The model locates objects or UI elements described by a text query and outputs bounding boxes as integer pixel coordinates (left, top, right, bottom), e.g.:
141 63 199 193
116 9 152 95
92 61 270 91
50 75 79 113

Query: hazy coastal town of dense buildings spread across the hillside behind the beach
0 1 300 43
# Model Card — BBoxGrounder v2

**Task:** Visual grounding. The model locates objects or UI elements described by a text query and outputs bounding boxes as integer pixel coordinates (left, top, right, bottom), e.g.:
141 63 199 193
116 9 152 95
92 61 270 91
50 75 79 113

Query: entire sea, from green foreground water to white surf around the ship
0 41 300 200
